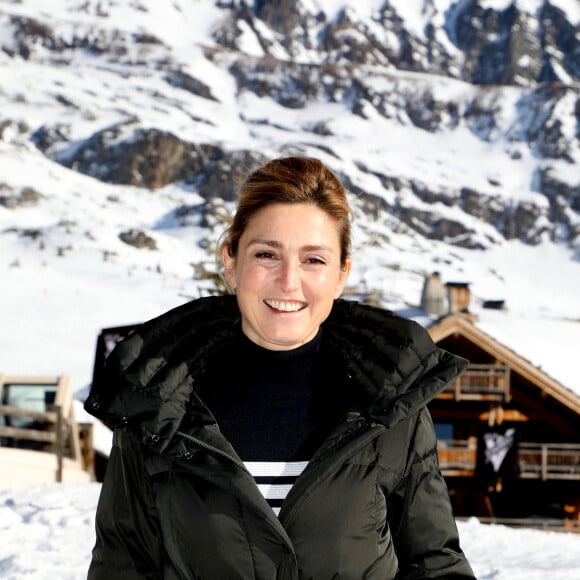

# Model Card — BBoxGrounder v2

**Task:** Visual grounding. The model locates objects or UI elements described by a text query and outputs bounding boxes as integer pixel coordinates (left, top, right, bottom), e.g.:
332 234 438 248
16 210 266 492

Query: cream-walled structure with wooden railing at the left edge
0 374 94 487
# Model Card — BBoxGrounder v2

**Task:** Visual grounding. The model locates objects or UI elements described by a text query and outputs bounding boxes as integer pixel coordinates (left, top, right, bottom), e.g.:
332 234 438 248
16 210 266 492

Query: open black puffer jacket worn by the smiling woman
85 297 473 580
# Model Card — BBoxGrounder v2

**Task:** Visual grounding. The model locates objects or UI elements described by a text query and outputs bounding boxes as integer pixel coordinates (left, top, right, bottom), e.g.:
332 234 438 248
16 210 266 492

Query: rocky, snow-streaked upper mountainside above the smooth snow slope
0 0 580 280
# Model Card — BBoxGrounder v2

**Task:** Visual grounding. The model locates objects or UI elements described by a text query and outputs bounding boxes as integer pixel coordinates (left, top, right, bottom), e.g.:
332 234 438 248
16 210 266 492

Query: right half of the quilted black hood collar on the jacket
324 300 469 427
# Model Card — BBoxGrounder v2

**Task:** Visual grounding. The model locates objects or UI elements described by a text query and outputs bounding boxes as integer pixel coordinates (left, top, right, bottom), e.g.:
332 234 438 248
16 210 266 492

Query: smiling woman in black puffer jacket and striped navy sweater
85 157 473 580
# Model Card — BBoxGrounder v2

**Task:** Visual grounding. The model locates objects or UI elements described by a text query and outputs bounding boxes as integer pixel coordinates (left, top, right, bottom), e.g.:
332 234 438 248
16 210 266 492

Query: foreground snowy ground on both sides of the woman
0 483 580 580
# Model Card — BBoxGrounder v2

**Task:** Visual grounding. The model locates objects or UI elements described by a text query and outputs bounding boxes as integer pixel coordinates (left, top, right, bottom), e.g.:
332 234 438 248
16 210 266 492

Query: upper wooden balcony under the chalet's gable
437 364 511 403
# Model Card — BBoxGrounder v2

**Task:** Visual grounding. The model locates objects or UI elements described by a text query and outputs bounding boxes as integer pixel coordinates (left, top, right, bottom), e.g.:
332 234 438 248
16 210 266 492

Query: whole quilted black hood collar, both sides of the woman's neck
85 296 468 448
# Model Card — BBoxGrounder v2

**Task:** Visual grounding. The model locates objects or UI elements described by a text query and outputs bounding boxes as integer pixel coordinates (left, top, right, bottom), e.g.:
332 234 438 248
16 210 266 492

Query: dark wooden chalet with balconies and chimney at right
428 285 580 531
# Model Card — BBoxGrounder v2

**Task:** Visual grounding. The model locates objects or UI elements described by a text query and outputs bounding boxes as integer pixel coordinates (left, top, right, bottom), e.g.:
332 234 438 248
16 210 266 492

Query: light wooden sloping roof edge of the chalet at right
426 313 580 415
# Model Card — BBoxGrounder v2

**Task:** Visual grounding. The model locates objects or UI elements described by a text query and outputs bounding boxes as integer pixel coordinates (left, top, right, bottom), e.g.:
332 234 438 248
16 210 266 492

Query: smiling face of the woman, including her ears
222 203 351 350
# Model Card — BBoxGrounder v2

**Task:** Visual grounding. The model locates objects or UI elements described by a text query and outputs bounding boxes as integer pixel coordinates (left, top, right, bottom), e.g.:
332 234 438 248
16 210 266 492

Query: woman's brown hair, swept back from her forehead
220 157 351 267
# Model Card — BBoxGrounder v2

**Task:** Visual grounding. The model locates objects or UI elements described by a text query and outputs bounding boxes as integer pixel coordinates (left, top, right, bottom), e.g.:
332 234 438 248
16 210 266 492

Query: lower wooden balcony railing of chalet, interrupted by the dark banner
437 438 580 481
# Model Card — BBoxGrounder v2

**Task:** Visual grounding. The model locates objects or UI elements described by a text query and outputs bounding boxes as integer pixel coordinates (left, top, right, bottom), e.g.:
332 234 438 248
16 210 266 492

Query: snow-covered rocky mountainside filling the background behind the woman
0 0 580 404
